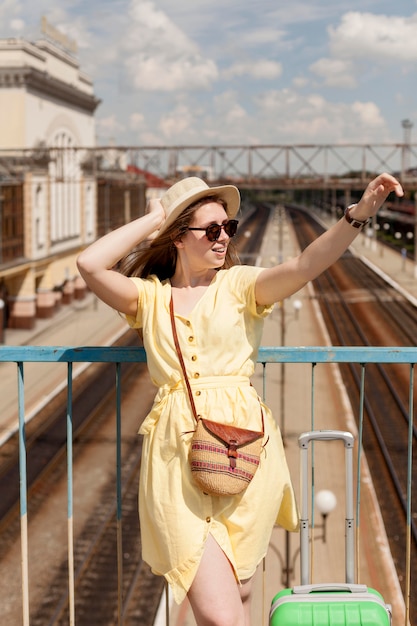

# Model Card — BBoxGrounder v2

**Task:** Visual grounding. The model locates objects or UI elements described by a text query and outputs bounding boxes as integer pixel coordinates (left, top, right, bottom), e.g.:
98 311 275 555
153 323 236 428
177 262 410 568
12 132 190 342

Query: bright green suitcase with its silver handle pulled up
269 430 392 626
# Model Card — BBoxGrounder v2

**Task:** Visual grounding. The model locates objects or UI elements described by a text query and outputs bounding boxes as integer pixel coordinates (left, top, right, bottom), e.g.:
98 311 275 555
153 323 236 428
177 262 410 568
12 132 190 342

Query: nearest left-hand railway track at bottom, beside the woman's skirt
31 420 163 626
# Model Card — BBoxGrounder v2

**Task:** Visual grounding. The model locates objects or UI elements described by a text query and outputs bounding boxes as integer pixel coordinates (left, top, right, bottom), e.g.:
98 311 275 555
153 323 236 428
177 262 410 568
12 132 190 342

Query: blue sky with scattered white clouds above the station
0 0 417 146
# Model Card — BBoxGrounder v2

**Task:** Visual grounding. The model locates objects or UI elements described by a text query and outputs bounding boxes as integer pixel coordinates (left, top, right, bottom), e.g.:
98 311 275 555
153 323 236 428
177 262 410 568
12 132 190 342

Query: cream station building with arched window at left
0 25 148 329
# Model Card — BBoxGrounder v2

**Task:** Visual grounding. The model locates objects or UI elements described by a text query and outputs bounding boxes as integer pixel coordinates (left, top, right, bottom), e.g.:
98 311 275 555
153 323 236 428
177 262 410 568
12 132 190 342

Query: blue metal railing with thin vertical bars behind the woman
0 346 417 626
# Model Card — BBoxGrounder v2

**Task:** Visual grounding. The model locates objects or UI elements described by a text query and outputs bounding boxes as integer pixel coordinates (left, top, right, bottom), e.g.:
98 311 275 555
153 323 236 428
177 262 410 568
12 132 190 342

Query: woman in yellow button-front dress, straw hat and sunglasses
78 174 403 626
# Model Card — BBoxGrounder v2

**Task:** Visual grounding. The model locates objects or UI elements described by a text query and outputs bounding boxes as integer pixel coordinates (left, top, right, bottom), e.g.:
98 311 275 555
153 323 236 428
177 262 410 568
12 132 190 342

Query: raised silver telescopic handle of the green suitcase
298 430 355 585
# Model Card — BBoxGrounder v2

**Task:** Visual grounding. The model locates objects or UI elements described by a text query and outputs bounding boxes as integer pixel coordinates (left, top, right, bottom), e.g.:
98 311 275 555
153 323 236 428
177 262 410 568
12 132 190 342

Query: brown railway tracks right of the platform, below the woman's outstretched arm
289 204 417 623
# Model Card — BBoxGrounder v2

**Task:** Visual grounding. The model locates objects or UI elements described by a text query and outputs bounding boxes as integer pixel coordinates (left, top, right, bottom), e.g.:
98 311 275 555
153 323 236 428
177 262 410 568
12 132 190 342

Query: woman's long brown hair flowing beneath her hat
117 195 240 280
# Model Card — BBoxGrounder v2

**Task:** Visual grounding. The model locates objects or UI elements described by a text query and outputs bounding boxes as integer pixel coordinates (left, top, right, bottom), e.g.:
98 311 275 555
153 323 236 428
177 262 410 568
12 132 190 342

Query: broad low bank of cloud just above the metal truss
127 83 389 145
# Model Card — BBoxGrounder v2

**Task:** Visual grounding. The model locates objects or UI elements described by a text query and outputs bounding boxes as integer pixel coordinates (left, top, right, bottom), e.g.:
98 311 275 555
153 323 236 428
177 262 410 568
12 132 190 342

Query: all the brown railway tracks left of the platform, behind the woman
0 205 270 626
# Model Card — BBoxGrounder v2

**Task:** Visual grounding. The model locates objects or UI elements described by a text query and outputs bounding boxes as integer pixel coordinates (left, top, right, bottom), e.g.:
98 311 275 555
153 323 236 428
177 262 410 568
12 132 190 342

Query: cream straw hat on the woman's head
158 176 240 234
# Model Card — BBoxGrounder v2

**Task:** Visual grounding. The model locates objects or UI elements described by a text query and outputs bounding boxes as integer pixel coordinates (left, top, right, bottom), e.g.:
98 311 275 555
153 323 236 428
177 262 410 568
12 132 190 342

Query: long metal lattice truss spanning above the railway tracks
0 143 417 189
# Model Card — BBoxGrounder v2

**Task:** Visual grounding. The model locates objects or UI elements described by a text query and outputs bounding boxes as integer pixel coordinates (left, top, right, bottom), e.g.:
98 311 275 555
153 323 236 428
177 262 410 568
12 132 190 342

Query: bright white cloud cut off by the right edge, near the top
328 11 417 64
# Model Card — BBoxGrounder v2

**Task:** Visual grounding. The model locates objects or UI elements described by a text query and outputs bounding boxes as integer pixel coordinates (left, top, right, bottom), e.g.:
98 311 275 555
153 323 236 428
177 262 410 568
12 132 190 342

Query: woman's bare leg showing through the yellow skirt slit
188 535 250 626
